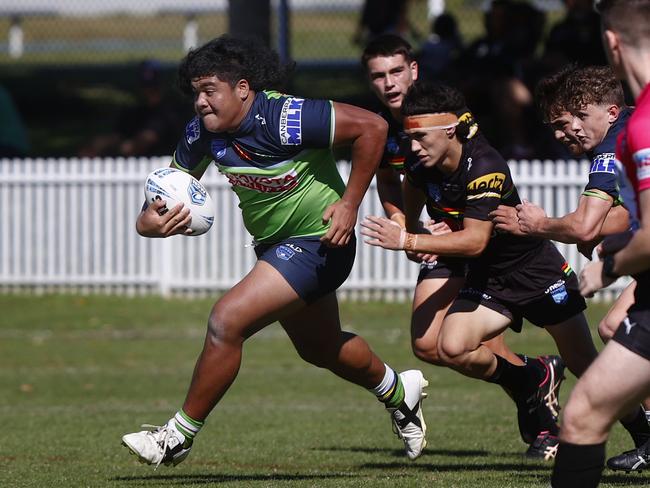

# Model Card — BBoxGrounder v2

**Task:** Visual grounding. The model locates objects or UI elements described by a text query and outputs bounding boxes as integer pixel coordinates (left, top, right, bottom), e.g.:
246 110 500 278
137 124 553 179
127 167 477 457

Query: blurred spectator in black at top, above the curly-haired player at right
544 0 607 72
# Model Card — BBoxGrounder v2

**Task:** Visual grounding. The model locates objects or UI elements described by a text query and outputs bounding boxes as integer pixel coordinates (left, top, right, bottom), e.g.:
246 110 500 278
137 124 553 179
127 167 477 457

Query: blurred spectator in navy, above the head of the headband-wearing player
417 12 463 80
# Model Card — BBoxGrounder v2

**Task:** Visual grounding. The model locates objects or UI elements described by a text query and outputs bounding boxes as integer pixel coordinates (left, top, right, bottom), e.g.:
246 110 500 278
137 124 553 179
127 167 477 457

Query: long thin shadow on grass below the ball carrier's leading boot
110 473 353 486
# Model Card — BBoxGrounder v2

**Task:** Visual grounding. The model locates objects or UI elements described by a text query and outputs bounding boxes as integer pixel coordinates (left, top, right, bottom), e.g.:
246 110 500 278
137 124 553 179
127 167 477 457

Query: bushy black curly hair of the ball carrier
178 35 295 95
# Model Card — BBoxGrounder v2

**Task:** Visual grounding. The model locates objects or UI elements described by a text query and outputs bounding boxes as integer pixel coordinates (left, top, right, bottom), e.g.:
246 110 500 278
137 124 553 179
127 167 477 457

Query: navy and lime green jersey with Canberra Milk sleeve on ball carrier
174 91 345 243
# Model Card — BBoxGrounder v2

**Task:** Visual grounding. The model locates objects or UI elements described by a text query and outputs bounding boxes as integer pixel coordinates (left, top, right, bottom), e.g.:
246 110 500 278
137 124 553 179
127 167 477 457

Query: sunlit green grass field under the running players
0 296 650 488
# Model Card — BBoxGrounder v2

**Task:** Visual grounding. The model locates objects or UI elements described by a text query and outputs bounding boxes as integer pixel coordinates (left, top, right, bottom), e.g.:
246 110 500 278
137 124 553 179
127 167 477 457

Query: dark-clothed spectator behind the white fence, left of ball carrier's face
79 60 184 157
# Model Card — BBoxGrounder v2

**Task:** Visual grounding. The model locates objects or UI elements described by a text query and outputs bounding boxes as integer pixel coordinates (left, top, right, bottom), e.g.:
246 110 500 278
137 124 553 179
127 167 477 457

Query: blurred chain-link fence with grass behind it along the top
0 0 562 64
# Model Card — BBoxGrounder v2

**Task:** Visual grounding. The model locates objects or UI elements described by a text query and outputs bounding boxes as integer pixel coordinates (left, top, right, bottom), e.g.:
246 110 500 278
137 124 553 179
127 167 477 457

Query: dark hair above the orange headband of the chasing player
402 81 466 116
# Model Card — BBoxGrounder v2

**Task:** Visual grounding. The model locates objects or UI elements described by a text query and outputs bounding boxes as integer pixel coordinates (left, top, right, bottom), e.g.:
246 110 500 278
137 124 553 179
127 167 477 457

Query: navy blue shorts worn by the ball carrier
255 234 357 303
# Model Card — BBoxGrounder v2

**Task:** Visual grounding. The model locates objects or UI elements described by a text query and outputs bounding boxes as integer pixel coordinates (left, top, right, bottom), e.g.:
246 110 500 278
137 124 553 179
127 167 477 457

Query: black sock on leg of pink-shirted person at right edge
551 442 605 488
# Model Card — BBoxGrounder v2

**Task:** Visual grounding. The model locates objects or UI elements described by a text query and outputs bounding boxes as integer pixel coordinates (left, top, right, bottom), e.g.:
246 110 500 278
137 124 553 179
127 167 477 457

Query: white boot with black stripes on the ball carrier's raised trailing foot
388 369 429 460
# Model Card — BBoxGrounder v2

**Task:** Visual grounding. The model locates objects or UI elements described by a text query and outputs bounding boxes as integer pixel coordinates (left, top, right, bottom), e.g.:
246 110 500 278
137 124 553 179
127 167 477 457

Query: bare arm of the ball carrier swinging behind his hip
321 103 388 247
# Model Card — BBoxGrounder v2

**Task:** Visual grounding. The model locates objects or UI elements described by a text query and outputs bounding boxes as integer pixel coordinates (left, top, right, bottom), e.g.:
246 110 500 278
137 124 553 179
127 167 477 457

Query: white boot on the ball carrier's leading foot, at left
122 418 192 468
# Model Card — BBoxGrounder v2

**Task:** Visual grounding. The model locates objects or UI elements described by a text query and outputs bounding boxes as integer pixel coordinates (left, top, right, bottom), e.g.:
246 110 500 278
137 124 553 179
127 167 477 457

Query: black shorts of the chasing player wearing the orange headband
448 241 587 332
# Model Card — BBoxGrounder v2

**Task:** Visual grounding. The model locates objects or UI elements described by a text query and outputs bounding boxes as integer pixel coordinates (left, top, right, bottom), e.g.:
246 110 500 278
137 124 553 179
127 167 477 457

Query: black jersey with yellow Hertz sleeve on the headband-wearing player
406 133 543 272
